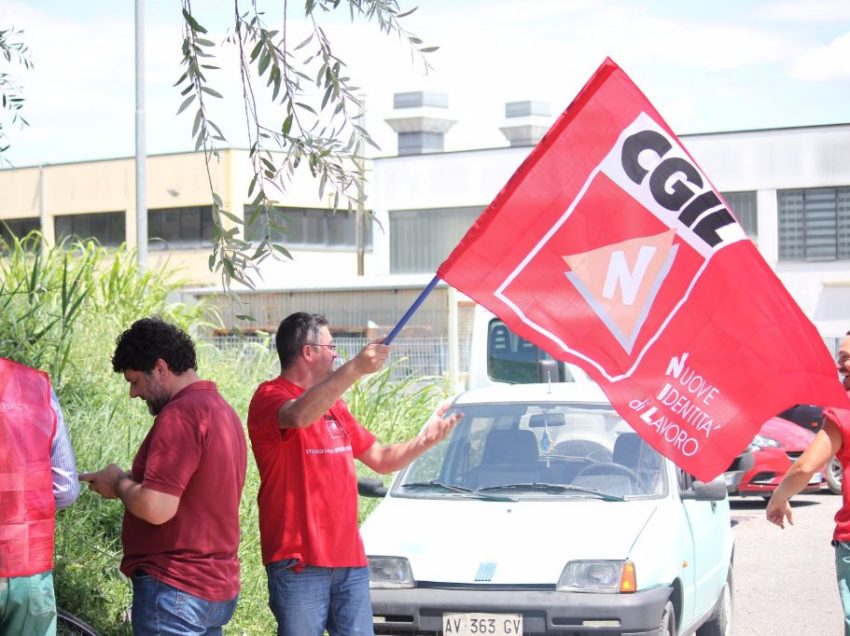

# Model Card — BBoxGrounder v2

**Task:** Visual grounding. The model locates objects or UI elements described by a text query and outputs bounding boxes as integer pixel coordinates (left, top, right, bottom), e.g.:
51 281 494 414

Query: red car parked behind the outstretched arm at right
730 417 823 499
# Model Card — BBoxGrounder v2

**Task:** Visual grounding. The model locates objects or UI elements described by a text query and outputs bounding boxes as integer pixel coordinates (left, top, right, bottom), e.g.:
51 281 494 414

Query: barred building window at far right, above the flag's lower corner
777 188 850 261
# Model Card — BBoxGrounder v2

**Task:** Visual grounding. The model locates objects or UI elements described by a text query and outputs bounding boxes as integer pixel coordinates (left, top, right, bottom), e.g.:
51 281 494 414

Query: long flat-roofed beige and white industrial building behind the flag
0 93 850 346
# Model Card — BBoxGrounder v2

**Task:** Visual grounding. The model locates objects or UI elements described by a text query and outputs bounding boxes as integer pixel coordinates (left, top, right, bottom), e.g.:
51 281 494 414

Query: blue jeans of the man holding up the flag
266 559 375 636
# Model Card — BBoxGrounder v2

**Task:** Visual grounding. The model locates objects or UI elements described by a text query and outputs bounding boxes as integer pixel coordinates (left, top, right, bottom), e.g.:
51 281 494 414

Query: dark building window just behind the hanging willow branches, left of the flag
240 206 373 249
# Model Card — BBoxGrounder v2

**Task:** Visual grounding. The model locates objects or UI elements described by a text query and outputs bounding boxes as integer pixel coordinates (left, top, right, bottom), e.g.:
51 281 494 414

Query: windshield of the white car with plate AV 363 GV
393 402 667 501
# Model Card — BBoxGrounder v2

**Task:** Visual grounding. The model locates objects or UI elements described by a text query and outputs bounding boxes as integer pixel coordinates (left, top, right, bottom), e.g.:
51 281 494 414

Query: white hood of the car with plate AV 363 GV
362 498 658 584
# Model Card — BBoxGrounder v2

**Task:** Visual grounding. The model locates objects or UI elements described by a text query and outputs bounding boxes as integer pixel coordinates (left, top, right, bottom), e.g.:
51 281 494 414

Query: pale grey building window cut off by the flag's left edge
390 206 484 274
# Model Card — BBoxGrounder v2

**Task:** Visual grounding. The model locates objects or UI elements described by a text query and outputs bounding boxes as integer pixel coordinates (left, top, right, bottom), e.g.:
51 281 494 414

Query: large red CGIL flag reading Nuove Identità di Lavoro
437 60 847 480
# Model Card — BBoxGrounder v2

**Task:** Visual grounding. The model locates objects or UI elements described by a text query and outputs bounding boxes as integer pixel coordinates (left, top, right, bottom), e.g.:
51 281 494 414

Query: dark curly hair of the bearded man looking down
112 316 198 375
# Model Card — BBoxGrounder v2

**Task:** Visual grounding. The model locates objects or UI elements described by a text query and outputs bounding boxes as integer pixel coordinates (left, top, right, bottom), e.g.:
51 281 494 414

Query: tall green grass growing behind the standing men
0 235 445 636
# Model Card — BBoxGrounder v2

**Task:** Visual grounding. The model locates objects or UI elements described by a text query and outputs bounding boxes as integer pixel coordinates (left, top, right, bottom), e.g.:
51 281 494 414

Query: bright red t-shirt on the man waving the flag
248 377 375 569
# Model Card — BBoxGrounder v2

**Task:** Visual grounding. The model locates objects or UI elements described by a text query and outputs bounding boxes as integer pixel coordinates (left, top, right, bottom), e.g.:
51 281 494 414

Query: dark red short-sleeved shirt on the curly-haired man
121 381 248 601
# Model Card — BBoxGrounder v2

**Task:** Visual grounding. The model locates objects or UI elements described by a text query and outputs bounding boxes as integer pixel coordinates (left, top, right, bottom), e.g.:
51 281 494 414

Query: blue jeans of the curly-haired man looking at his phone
132 571 238 636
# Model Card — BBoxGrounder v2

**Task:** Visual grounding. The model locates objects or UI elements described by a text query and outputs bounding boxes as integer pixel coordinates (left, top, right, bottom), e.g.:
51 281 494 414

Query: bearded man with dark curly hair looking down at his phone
80 318 247 636
